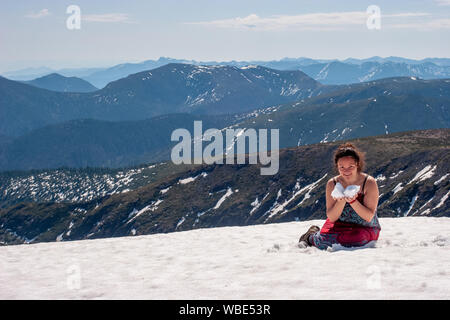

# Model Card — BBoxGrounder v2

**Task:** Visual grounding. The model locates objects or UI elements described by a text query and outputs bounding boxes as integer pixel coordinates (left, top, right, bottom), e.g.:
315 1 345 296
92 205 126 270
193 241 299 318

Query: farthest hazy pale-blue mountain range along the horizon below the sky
3 56 450 88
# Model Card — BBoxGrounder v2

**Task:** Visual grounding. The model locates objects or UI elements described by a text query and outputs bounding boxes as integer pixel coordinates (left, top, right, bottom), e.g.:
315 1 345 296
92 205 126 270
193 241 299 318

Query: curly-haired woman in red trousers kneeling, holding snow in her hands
300 143 381 249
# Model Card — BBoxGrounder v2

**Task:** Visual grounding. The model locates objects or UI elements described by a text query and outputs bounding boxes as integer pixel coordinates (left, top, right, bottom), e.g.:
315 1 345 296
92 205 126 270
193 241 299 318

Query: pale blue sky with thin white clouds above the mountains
0 0 450 72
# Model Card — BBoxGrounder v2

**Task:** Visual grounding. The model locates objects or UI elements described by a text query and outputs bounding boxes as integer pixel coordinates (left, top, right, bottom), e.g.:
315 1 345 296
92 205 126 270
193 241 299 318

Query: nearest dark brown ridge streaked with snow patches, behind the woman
0 129 450 244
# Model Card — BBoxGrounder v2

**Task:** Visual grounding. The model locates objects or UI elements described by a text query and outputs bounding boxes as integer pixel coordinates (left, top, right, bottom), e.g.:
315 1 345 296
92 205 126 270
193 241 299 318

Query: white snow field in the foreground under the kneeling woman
0 217 450 299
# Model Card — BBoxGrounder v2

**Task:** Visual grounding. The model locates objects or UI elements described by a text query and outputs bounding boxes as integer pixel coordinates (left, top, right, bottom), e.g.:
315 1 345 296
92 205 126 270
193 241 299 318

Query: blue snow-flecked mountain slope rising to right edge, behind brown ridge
239 77 450 147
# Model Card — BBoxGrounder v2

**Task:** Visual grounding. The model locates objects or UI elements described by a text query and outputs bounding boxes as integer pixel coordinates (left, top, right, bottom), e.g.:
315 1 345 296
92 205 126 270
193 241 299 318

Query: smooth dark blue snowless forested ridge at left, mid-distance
0 113 241 170
